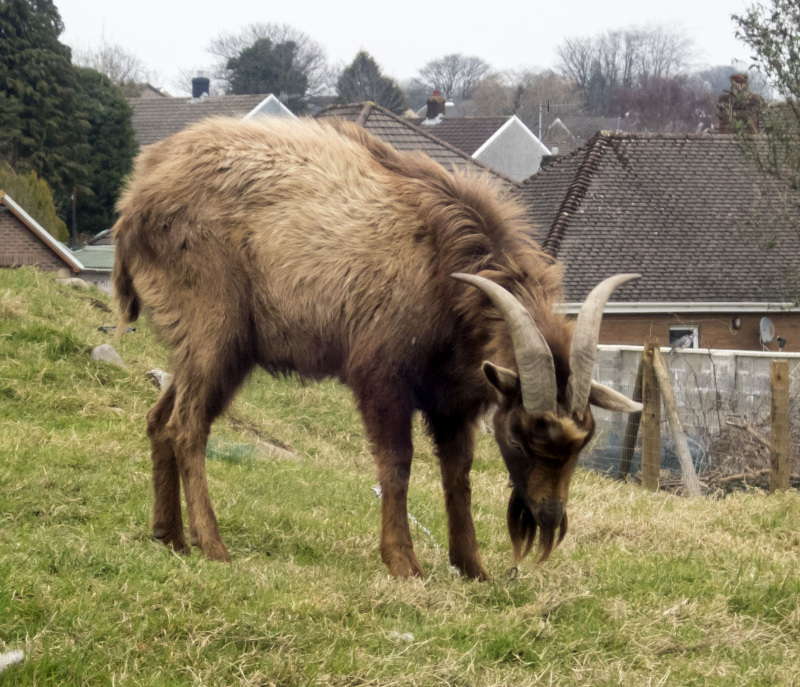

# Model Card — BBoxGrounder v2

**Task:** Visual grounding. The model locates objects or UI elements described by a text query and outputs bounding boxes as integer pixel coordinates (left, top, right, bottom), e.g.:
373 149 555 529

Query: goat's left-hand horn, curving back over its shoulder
450 273 558 415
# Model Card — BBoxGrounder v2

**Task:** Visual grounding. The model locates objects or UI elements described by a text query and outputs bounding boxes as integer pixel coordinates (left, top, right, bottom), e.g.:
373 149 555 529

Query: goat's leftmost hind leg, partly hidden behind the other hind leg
147 385 190 553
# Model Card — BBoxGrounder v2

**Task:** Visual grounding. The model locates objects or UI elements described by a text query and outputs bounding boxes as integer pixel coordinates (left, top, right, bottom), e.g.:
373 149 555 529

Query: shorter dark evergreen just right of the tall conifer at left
75 67 138 234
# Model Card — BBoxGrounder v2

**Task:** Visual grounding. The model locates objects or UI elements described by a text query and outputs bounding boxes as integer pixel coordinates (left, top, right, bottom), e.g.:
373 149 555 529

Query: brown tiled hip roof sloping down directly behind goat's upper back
316 103 520 191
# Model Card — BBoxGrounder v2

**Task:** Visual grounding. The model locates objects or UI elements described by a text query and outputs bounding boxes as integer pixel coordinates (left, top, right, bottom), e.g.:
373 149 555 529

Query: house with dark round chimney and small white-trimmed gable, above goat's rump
128 77 294 146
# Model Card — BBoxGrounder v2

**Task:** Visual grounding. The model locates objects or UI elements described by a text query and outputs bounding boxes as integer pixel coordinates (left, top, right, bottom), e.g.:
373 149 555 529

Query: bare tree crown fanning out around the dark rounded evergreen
208 22 336 96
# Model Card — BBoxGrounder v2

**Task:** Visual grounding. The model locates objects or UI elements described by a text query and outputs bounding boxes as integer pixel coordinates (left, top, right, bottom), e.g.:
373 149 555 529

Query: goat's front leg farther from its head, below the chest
362 396 423 577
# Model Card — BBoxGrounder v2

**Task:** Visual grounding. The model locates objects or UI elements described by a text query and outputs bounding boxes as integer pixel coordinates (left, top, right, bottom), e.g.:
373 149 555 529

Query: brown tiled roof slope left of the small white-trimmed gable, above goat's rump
128 95 267 146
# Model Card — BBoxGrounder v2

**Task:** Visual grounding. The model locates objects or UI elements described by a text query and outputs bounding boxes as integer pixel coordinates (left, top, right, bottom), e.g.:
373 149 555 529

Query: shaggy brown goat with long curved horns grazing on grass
114 119 639 578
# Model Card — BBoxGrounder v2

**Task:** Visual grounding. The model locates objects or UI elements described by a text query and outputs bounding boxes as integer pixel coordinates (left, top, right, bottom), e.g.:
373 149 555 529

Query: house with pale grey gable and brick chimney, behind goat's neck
412 91 550 181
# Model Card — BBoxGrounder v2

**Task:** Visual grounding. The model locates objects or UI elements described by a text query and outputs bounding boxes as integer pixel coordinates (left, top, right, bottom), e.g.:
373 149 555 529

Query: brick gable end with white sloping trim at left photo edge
0 191 84 276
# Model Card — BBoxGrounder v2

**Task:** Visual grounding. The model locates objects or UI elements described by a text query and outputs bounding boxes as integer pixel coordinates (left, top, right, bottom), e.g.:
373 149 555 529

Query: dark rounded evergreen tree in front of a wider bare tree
227 38 308 113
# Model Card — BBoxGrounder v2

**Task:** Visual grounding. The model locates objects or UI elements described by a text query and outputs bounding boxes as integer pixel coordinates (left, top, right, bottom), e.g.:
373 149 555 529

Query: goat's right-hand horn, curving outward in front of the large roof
567 274 642 413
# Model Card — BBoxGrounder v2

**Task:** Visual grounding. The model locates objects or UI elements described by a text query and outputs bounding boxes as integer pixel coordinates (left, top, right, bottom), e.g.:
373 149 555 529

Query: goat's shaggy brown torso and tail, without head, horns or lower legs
115 118 558 390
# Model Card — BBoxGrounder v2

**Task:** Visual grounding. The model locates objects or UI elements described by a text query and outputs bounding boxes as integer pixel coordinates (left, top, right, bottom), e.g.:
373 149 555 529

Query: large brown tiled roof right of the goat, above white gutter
522 132 800 303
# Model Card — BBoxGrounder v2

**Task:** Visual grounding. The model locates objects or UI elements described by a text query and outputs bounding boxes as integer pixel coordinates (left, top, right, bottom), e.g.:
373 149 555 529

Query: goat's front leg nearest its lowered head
428 416 489 580
